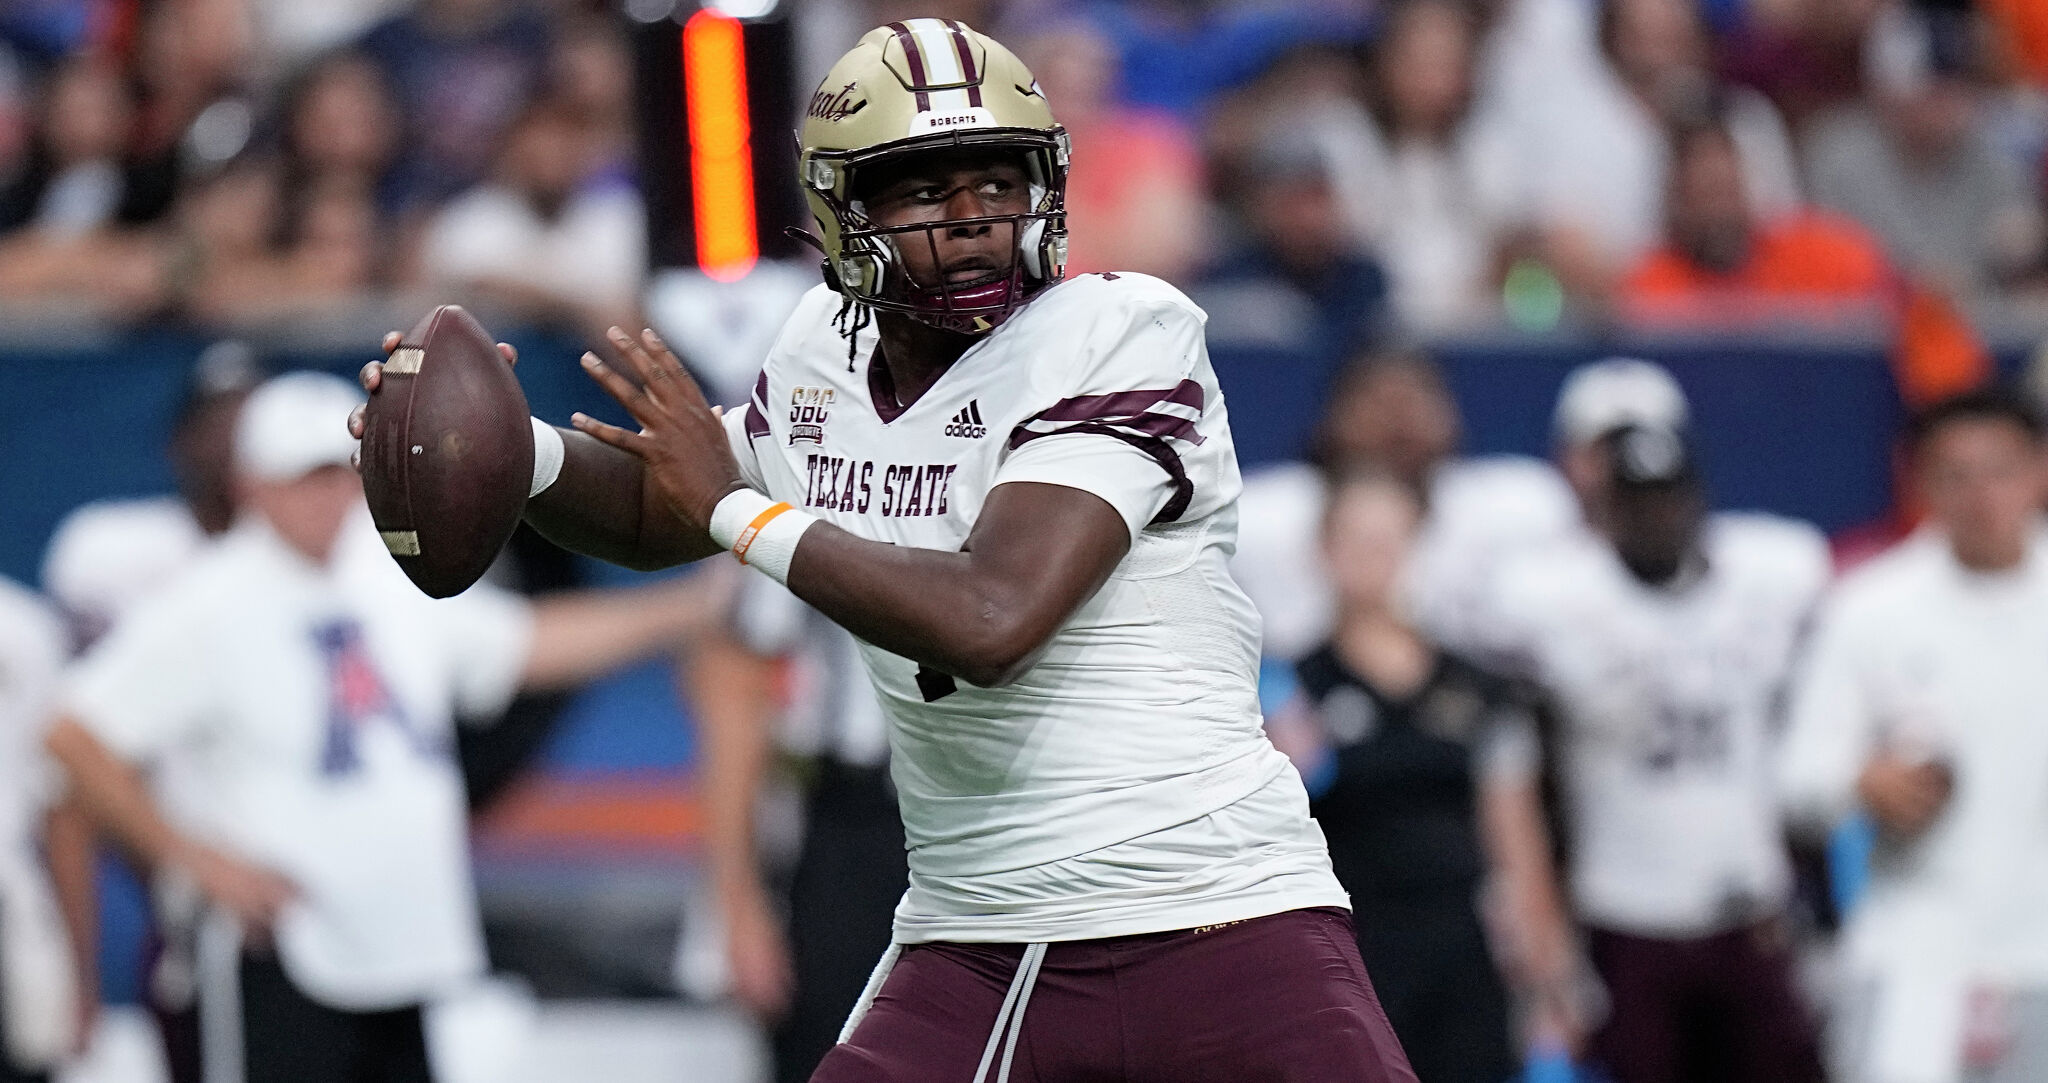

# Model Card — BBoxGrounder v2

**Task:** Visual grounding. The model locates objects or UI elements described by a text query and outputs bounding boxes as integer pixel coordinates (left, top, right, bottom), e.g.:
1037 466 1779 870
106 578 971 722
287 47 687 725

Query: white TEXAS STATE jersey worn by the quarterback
727 274 1343 942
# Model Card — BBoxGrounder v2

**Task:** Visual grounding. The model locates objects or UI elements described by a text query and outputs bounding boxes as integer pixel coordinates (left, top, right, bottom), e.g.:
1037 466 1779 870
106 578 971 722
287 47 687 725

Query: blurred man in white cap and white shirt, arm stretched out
47 373 729 1083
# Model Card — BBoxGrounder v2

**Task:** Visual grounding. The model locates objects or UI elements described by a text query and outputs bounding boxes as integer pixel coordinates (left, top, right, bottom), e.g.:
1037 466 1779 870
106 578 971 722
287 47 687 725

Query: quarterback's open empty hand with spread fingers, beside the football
569 328 745 530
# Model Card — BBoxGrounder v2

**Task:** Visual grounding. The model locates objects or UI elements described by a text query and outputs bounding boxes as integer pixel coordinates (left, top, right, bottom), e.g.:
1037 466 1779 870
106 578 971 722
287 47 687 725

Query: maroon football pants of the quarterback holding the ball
811 909 1415 1083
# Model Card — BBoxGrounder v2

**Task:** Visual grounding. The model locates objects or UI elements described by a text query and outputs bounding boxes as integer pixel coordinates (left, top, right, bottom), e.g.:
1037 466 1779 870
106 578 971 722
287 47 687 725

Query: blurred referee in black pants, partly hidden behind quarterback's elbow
690 577 909 1083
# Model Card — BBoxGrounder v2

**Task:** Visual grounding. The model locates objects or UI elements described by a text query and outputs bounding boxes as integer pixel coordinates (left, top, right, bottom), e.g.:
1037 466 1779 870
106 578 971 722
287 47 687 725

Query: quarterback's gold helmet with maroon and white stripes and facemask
797 18 1069 334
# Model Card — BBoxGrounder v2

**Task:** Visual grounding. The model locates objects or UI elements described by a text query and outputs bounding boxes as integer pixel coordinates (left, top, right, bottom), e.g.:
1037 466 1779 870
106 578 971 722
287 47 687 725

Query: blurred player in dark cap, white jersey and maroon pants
1501 426 1829 1083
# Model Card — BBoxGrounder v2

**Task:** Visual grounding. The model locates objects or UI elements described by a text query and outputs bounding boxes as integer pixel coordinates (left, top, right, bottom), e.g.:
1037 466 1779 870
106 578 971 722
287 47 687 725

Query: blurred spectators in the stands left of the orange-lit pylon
0 0 645 328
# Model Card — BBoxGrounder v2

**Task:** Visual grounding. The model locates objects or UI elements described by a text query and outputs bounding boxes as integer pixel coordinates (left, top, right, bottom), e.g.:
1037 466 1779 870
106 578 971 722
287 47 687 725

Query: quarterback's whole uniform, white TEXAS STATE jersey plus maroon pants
727 274 1415 1083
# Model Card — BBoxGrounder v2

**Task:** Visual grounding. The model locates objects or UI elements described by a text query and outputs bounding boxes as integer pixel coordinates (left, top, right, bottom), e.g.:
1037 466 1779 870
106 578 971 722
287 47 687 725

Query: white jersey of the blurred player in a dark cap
1501 516 1831 936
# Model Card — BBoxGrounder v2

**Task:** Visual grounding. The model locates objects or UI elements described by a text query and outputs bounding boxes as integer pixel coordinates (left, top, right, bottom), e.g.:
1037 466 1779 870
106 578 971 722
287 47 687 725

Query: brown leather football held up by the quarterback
362 305 532 598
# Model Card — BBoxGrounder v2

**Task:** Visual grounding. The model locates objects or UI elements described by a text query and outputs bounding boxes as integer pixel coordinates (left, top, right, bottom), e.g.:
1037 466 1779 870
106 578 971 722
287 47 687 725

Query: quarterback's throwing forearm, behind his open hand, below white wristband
526 428 719 571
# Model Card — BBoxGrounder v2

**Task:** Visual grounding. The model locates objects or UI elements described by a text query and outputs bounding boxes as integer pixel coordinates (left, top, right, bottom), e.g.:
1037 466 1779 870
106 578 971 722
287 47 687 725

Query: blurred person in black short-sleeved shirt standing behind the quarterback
1268 471 1581 1083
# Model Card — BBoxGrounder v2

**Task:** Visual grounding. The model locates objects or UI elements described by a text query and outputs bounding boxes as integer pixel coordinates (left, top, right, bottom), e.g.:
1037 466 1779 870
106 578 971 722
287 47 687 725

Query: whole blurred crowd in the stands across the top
0 0 2048 354
